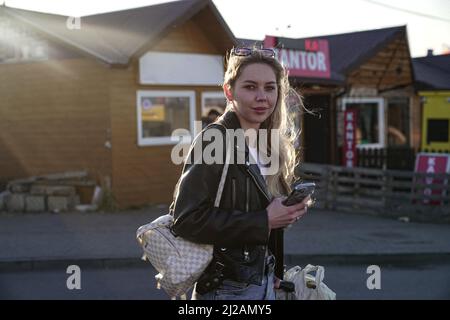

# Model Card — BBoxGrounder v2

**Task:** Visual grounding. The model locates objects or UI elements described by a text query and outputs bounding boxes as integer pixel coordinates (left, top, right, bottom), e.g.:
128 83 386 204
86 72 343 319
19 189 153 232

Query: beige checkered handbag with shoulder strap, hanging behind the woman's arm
136 129 229 299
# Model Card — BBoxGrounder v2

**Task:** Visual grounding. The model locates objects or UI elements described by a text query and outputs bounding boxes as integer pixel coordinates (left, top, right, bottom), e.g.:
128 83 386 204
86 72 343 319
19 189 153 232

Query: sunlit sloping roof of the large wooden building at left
0 0 235 64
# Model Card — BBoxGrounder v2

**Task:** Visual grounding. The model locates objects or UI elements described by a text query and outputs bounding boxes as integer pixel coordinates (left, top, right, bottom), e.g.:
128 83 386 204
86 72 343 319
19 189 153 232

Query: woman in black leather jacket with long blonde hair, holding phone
171 48 309 300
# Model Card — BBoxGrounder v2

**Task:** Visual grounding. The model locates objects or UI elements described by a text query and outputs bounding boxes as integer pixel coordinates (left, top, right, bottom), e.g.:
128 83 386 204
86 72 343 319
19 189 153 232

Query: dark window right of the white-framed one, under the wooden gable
387 98 410 146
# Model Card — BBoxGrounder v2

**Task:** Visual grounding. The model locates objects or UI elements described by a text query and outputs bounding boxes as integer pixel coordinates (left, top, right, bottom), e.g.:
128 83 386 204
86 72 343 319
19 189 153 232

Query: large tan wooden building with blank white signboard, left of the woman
0 0 235 207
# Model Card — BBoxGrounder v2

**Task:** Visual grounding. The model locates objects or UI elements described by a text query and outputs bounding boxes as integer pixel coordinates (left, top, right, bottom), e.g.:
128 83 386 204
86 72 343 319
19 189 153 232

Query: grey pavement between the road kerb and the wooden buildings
0 202 450 270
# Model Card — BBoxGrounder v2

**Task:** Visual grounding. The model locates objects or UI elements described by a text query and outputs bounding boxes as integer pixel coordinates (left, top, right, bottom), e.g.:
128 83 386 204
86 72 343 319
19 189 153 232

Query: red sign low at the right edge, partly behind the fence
415 153 450 205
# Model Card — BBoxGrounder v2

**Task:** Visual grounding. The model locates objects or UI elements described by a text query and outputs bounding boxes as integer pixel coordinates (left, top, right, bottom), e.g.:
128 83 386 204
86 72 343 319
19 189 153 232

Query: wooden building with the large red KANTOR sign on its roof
240 26 421 169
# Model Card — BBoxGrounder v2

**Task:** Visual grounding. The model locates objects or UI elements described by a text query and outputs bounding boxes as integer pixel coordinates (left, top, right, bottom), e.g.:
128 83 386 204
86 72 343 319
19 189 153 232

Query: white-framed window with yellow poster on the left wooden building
137 91 195 146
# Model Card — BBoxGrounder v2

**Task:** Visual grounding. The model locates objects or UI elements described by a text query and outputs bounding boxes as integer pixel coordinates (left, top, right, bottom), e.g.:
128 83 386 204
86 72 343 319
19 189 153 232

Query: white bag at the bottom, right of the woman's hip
284 264 336 300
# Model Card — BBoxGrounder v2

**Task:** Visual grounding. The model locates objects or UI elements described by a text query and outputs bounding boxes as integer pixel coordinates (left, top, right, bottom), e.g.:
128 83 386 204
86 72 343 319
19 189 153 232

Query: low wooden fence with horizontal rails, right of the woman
297 163 450 222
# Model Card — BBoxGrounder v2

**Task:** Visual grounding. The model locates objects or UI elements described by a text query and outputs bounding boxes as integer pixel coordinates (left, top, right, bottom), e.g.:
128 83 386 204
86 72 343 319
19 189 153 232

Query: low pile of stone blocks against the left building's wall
0 171 95 213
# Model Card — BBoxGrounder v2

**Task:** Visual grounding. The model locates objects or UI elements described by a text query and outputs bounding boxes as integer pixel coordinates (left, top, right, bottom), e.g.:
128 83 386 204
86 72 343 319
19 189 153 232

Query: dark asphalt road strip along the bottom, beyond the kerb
0 262 450 300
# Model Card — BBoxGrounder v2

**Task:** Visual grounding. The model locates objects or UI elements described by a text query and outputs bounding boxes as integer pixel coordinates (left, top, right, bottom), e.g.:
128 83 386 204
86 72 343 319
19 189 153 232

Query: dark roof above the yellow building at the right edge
412 54 450 90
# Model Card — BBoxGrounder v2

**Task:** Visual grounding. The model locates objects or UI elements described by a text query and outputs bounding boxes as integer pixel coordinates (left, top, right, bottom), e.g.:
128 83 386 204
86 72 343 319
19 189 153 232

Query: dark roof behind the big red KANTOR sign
238 26 406 83
